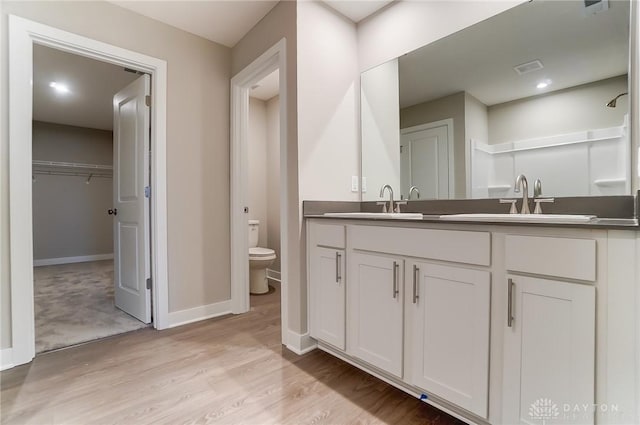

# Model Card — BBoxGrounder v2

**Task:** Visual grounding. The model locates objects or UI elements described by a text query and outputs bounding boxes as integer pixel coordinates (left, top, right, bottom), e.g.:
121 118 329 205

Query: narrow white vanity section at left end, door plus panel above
308 224 346 350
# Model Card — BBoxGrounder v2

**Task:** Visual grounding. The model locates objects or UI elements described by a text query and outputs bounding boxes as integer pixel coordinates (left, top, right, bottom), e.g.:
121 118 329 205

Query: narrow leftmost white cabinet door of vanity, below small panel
309 246 345 350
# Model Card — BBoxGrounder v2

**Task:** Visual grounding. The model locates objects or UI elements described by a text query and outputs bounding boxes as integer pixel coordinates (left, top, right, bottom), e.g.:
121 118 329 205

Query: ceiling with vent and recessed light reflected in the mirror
399 1 629 107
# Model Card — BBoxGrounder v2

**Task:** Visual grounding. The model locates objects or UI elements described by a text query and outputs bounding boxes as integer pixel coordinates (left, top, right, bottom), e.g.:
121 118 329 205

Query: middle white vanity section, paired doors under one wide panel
347 225 491 398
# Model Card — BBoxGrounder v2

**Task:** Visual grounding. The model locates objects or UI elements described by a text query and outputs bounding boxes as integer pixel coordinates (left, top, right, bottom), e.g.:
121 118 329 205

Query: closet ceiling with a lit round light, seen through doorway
33 44 138 130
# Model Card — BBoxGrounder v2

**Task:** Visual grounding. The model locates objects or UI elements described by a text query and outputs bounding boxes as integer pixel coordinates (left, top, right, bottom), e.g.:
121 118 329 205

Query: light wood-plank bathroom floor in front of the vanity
0 284 461 425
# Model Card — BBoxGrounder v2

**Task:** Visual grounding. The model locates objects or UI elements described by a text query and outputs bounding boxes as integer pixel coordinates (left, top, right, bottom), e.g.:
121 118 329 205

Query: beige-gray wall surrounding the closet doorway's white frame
0 1 232 348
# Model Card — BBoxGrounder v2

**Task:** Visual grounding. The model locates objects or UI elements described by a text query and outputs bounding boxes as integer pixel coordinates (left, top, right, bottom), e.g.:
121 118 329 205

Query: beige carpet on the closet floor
34 260 147 353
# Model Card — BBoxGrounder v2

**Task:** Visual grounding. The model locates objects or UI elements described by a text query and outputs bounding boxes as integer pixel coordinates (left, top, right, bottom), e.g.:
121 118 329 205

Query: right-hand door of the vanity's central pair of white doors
407 262 491 418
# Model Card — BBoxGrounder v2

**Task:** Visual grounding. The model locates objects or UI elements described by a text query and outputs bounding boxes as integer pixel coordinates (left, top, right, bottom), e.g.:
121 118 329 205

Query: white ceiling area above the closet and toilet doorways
111 0 278 47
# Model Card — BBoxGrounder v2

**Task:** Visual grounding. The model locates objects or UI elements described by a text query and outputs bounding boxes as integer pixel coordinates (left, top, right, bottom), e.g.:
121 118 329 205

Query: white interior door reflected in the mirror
400 125 449 199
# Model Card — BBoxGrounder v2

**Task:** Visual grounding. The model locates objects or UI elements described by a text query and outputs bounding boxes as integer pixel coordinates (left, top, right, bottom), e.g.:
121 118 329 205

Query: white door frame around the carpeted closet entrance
8 15 169 365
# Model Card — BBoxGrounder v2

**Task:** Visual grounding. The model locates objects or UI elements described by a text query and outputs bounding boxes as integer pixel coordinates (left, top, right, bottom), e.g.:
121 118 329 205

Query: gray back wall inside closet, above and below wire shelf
32 121 113 260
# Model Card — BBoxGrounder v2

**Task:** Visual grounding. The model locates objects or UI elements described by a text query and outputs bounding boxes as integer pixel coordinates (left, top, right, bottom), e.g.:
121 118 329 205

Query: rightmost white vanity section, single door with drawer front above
502 235 596 424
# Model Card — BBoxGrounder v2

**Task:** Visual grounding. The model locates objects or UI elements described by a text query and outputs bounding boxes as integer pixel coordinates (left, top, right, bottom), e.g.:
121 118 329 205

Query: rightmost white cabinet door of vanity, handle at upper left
503 275 595 424
